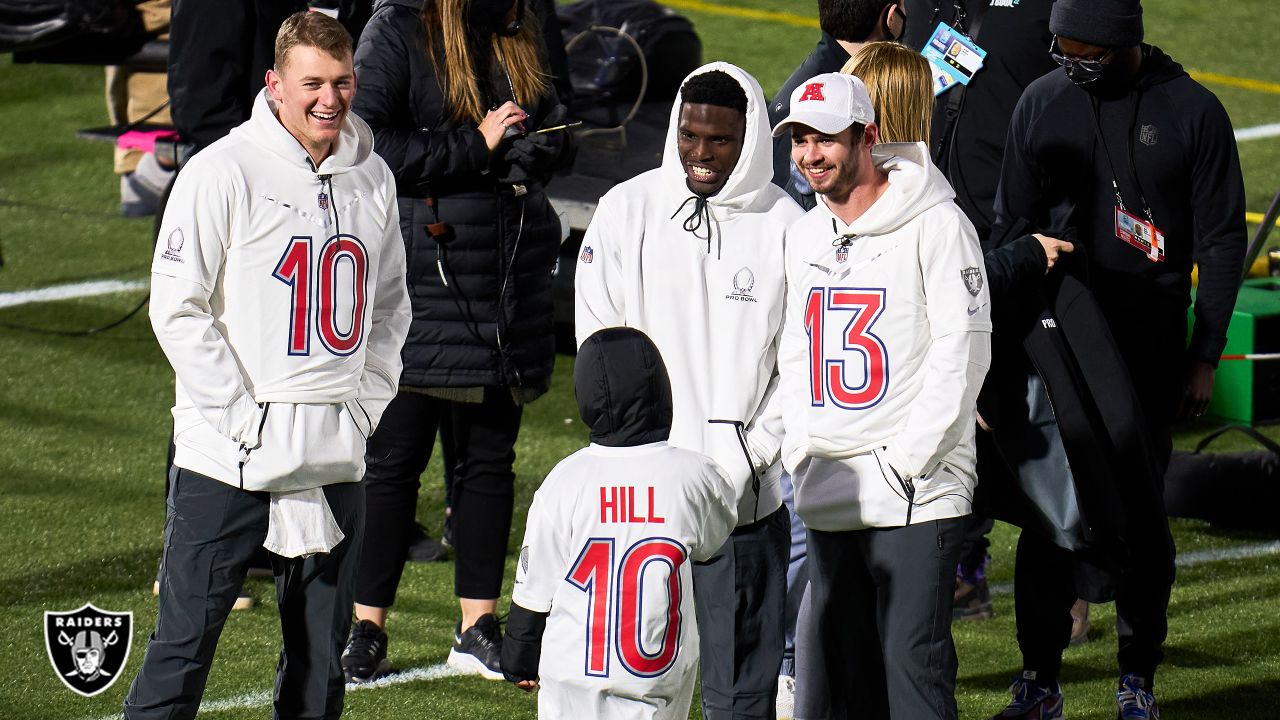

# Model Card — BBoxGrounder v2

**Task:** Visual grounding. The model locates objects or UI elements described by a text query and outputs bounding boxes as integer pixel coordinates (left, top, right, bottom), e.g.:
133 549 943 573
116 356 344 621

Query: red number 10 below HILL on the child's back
564 538 687 678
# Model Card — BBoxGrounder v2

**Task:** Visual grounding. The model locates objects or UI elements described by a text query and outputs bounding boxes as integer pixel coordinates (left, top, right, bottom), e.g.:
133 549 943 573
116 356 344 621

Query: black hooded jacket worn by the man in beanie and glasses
992 45 1245 386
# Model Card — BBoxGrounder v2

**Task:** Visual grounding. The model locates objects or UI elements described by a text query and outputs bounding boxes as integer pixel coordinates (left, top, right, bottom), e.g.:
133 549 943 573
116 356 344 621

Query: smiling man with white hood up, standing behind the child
576 63 801 720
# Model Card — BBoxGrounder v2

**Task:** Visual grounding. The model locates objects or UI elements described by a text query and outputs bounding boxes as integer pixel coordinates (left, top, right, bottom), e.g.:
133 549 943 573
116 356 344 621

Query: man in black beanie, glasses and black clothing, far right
993 0 1245 720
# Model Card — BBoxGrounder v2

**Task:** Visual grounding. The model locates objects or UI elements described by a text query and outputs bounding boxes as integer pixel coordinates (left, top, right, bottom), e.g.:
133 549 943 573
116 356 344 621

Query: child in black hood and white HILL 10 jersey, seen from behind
502 328 737 720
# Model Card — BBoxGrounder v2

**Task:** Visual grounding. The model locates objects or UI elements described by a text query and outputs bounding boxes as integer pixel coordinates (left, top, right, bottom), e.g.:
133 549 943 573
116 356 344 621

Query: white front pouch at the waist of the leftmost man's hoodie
242 401 369 492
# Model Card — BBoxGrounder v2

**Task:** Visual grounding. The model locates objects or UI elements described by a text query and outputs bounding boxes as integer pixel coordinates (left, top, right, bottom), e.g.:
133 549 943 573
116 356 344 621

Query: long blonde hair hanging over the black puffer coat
422 0 550 124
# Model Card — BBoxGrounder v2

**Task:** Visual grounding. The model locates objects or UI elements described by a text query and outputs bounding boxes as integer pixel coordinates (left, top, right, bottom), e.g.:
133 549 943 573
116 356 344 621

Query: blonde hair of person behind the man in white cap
840 41 933 145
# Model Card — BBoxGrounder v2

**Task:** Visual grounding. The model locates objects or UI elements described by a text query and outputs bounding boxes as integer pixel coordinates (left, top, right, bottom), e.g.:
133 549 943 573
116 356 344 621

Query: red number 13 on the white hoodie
804 287 888 410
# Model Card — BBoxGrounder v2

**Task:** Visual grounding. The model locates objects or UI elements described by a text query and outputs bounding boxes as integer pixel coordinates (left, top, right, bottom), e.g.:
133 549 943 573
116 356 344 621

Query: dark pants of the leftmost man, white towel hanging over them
124 468 365 720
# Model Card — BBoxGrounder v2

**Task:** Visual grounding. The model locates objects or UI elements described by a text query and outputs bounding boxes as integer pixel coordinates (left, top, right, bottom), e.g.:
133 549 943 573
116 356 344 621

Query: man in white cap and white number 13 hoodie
774 73 991 720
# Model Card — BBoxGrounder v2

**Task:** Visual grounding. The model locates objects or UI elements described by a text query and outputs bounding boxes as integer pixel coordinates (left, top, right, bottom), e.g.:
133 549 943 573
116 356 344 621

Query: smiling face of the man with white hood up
676 102 746 195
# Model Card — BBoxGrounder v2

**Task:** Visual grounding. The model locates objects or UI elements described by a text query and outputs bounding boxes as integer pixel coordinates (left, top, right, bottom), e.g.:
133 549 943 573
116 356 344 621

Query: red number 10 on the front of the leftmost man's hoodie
273 234 369 355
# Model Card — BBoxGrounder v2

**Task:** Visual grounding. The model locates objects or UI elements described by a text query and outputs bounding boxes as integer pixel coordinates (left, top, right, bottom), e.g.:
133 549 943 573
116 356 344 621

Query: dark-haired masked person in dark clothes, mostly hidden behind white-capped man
769 0 906 210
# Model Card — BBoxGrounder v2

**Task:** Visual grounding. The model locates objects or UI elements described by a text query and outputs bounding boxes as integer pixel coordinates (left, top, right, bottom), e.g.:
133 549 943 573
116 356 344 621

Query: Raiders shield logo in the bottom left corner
45 603 133 697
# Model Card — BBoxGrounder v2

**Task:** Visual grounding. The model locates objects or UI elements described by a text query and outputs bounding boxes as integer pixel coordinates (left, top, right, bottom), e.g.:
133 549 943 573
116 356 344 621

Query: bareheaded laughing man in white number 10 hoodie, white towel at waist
124 13 410 720
